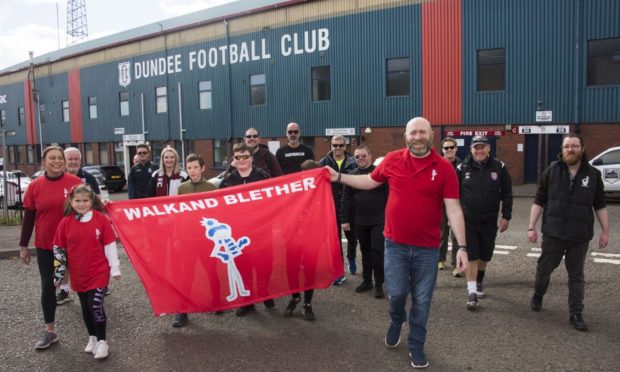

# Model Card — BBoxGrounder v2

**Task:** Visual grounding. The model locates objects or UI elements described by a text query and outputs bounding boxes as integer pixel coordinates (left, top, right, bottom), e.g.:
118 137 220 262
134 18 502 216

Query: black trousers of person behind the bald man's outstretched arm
355 224 385 284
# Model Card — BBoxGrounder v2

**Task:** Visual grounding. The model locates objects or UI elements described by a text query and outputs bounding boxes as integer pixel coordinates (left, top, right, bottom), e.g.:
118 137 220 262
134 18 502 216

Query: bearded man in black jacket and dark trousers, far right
527 133 609 331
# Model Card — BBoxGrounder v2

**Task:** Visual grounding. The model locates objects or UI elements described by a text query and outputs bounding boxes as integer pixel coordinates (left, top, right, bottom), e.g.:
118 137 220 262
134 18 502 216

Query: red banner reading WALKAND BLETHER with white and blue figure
106 169 343 315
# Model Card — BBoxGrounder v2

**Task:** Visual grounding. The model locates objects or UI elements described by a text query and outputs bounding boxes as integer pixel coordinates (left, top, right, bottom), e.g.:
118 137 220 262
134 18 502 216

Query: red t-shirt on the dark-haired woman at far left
24 173 83 251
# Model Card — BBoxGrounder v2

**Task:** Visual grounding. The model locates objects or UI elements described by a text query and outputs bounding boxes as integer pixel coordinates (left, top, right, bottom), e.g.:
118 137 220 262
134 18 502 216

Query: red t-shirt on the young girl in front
54 211 116 292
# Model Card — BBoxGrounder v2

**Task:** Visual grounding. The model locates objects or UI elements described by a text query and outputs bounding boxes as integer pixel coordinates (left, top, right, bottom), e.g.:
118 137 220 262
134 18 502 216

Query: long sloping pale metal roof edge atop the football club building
0 0 311 75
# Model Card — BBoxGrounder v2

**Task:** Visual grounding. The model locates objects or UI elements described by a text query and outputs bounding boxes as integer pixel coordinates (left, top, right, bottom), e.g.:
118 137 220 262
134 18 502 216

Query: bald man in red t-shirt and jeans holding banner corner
326 117 468 368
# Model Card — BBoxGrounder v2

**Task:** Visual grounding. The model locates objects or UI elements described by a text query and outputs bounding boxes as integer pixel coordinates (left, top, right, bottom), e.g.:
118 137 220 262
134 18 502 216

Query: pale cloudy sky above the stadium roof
0 0 235 70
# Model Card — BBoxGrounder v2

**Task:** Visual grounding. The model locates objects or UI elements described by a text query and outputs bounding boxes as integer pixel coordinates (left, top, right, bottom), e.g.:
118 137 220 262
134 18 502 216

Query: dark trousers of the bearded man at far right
534 235 590 314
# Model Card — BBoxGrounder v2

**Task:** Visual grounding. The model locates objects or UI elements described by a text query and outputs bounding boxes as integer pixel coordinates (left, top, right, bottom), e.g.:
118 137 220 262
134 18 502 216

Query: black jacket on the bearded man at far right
534 160 605 242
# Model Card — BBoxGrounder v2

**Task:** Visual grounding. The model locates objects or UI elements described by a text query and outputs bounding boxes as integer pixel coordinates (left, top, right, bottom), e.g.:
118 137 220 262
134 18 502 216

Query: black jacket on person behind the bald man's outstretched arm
340 165 388 226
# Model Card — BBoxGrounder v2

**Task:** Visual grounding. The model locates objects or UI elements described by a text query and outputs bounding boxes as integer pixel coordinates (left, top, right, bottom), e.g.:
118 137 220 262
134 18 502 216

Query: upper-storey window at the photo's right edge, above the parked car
588 37 620 86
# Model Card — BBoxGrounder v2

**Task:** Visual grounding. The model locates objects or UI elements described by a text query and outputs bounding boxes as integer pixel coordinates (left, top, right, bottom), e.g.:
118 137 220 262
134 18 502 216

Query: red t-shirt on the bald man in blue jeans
370 148 459 249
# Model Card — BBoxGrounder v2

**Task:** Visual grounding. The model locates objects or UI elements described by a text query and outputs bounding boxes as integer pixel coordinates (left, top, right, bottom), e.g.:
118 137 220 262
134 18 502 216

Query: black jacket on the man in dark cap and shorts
456 155 512 224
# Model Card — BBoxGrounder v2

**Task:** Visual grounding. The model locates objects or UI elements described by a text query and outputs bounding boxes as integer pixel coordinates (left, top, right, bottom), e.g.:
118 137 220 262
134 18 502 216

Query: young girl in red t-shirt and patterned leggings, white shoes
54 185 121 359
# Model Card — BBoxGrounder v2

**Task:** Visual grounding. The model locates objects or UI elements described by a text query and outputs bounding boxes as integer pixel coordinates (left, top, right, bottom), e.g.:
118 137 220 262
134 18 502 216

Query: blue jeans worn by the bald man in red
384 238 439 352
